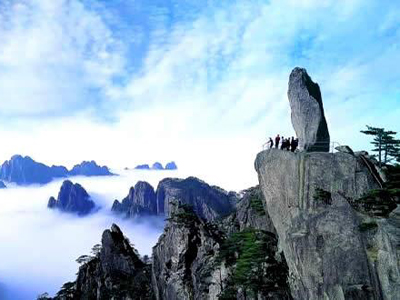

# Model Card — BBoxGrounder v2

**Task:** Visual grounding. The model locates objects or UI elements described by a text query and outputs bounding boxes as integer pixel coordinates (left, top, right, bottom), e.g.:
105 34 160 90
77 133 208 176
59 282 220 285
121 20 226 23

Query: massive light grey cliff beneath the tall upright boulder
255 149 400 299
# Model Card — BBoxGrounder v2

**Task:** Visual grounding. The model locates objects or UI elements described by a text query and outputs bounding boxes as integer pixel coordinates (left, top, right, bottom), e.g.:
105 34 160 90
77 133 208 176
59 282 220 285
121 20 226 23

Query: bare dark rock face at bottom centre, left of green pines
152 204 221 300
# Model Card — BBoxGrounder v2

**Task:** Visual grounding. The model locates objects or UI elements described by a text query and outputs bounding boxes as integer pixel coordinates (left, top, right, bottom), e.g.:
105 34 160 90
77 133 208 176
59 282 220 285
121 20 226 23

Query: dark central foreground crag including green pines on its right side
152 205 291 300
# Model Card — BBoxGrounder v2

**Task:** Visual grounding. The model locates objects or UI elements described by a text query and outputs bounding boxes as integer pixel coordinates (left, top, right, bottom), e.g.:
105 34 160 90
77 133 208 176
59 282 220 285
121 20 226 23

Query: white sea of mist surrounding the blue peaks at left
0 170 183 300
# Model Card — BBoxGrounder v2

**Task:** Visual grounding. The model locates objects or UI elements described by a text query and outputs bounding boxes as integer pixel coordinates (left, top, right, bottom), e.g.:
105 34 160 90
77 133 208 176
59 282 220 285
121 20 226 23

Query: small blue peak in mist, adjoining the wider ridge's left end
111 181 157 218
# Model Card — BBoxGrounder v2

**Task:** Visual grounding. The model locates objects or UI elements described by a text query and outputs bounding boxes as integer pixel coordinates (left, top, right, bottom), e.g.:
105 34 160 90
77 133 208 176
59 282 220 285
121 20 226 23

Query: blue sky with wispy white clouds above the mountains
0 0 400 189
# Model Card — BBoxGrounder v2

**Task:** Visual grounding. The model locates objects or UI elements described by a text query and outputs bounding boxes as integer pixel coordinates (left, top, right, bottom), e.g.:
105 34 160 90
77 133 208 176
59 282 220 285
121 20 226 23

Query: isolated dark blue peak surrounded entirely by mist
47 180 96 216
